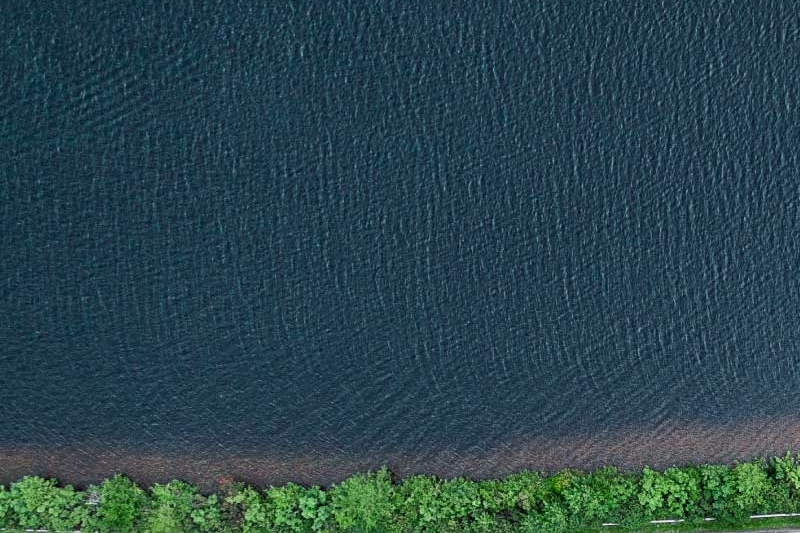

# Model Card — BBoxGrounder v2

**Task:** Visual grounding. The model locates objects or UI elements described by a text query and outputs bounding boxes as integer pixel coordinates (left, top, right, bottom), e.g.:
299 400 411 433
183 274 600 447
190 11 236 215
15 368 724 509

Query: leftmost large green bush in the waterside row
4 476 88 531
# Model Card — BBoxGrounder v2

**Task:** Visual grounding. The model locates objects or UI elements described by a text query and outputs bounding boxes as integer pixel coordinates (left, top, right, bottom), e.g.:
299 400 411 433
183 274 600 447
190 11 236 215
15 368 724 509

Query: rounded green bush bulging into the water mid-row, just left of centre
330 467 398 533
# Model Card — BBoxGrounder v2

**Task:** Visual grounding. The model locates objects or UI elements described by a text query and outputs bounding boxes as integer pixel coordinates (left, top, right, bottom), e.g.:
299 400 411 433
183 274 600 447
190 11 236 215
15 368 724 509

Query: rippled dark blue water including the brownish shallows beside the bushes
0 0 800 483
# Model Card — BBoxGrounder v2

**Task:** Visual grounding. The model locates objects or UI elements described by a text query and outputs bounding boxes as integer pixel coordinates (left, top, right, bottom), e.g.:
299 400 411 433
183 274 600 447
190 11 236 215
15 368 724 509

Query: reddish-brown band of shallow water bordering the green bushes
0 418 800 490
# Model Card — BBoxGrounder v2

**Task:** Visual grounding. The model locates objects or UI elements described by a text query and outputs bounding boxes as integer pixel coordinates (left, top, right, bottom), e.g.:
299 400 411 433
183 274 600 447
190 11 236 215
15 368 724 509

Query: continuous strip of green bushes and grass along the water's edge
0 453 800 533
